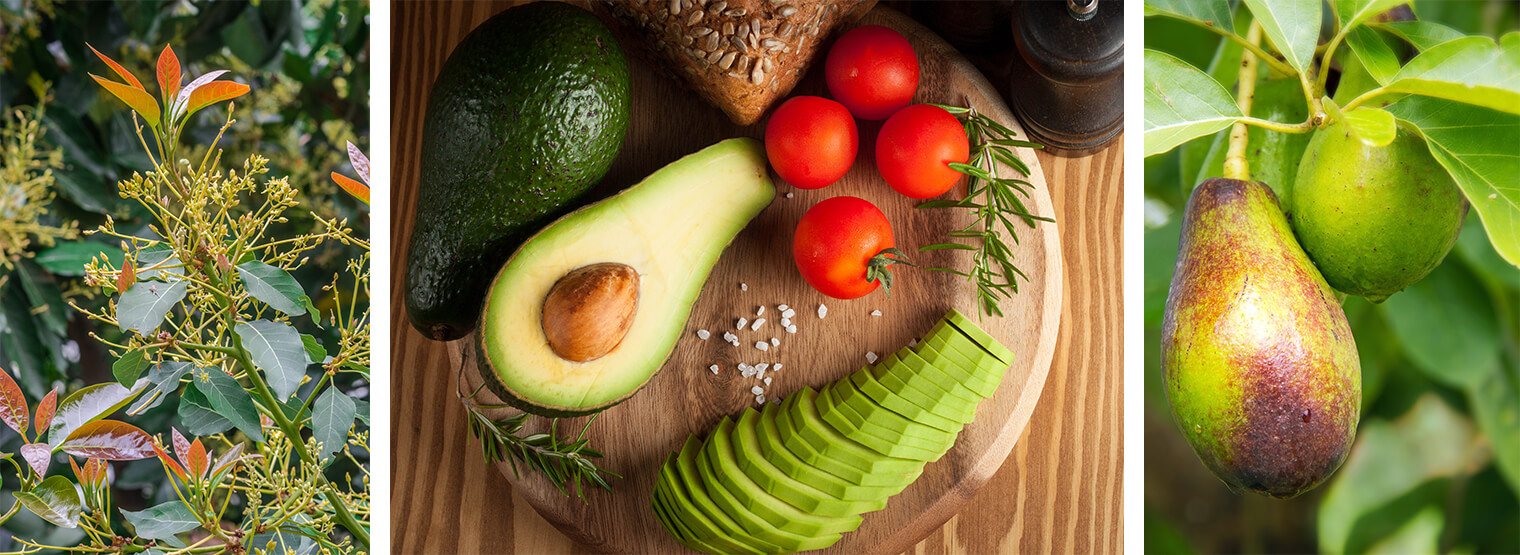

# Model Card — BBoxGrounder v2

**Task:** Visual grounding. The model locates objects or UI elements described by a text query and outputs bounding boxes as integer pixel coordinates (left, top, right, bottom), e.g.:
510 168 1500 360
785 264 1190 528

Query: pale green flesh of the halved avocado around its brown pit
479 138 775 417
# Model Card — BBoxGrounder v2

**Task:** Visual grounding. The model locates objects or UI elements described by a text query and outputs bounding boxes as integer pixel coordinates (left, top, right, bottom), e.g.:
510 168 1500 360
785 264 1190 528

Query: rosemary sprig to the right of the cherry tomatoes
918 102 1055 316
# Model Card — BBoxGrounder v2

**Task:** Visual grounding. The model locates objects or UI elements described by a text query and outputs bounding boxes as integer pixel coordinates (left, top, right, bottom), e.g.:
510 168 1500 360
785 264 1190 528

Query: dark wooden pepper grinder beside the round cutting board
1009 0 1125 157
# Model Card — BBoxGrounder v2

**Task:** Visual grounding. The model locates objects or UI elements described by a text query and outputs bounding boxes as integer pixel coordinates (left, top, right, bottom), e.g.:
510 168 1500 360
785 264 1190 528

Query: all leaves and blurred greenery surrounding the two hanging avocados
1145 0 1520 553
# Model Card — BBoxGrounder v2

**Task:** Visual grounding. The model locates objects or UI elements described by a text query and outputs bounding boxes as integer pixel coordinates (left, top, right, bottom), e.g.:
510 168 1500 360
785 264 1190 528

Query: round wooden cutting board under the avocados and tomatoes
450 8 1061 553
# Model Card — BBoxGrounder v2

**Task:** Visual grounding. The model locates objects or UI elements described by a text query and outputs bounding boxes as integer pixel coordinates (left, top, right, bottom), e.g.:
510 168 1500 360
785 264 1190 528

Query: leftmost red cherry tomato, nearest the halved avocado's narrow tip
765 96 860 189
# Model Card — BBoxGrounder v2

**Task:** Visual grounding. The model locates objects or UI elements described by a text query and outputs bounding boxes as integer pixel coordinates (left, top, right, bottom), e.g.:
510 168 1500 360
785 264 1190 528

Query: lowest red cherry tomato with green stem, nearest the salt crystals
792 196 892 300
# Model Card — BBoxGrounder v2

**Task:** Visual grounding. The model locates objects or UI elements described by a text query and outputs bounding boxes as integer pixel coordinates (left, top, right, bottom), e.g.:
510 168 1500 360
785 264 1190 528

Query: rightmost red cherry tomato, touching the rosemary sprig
876 103 971 199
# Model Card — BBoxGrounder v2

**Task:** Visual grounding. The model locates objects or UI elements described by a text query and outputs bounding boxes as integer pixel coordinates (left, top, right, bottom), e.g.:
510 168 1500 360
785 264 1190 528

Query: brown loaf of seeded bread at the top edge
593 0 876 125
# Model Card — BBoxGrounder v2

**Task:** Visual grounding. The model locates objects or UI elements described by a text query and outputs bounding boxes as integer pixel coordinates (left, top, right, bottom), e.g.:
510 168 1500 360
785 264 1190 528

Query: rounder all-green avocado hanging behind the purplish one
1290 122 1468 303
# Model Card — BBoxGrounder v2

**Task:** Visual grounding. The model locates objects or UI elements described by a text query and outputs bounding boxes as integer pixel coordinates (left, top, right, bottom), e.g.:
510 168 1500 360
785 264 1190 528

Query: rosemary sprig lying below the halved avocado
456 357 623 502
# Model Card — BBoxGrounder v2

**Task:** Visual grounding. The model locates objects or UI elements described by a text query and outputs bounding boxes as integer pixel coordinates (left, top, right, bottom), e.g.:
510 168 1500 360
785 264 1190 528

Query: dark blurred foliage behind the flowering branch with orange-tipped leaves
0 0 371 552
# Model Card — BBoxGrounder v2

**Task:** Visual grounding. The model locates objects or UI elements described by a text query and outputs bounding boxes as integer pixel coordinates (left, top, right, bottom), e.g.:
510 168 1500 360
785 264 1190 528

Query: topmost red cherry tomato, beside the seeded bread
824 24 918 120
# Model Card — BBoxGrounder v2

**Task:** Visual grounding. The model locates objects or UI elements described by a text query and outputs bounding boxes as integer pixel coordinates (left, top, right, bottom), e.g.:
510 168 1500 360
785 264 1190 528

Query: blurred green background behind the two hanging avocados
1145 0 1520 553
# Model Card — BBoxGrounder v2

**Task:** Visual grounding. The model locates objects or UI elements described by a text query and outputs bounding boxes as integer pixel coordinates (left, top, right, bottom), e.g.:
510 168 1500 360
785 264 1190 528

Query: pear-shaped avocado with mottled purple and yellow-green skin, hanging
1161 178 1362 499
